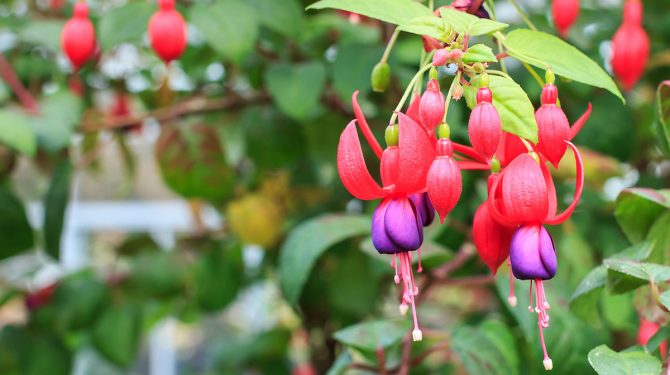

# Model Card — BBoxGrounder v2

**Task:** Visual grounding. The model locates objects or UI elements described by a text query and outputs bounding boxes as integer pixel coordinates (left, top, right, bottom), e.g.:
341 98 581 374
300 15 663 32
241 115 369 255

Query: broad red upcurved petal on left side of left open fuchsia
337 120 385 200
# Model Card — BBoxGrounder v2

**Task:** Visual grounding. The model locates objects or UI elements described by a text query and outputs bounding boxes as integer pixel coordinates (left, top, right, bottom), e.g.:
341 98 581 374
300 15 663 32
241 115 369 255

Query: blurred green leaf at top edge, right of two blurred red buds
190 0 258 64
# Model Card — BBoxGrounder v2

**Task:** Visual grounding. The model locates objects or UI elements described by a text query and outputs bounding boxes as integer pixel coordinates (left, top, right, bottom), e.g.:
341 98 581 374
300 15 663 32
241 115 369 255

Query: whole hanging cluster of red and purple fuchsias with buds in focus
337 14 591 369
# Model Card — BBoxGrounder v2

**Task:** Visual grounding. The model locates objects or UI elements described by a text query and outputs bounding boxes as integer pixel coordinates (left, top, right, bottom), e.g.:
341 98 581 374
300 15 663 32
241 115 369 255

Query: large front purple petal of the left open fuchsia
384 197 423 251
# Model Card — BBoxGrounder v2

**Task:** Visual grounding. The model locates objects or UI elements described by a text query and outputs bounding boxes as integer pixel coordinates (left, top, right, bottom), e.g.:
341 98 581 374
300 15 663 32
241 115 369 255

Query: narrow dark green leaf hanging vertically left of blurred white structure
44 160 72 259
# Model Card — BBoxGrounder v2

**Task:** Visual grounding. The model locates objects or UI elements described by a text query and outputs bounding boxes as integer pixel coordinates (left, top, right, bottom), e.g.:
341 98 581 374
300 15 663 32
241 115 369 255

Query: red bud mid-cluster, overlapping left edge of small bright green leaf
468 87 502 161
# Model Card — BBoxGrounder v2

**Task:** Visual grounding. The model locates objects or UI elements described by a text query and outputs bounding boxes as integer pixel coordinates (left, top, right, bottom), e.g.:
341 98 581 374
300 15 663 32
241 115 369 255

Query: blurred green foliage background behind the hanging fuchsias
0 0 670 375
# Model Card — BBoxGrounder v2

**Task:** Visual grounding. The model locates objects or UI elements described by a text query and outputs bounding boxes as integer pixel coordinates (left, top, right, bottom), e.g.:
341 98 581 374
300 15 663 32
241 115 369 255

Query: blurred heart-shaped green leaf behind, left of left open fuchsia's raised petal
265 62 326 121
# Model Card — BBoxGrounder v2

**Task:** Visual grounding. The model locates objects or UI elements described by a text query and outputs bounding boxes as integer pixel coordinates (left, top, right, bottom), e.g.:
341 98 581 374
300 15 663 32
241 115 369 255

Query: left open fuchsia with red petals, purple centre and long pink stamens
337 92 435 341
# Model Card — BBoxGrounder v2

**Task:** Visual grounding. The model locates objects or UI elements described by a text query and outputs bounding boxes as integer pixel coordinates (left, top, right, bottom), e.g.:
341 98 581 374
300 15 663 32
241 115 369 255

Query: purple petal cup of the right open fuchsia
510 225 557 280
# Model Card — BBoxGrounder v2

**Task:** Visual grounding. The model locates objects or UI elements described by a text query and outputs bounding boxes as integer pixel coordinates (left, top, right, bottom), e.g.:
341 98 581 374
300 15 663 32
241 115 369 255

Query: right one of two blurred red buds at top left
149 0 186 64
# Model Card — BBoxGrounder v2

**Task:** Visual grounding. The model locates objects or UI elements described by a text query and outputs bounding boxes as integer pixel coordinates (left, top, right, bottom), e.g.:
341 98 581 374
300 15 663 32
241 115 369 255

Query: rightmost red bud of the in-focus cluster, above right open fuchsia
535 83 570 168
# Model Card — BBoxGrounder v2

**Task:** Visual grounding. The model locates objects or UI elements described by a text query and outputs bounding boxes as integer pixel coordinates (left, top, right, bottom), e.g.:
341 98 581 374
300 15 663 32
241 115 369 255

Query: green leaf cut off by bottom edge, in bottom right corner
589 345 661 375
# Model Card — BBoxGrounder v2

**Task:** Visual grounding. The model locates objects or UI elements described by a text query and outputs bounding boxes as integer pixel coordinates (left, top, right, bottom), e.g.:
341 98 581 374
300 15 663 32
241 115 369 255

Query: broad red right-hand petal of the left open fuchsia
396 113 435 194
